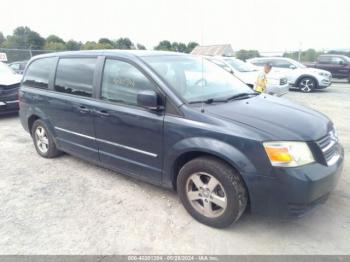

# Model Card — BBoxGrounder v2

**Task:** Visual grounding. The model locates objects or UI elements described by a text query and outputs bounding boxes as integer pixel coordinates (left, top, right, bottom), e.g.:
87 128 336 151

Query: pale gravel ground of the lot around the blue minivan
0 83 350 254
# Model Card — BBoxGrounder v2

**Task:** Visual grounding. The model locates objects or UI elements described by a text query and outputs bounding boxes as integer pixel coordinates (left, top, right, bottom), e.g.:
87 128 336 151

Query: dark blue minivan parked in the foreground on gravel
19 50 344 227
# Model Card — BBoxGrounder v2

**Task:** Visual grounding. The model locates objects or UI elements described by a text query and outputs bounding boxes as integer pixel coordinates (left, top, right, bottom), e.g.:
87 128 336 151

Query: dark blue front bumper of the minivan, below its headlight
245 144 344 217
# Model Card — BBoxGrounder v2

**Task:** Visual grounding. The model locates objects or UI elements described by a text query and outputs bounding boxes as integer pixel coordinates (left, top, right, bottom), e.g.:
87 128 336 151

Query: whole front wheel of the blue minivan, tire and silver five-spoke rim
177 157 248 228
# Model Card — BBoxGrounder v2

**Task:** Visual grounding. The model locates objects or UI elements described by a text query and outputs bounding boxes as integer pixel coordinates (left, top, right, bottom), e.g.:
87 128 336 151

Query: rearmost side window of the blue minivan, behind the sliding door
23 57 57 89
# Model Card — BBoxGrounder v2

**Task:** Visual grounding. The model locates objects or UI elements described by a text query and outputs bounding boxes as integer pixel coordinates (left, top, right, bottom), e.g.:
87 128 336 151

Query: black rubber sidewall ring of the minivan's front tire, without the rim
177 158 241 228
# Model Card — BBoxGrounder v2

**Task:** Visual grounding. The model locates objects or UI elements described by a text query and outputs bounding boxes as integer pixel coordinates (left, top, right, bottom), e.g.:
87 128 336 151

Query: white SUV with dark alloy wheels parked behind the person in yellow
247 57 332 93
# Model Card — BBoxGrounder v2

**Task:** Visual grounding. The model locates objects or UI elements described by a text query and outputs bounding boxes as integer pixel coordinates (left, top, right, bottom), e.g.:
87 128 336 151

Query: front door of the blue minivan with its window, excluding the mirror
94 59 164 183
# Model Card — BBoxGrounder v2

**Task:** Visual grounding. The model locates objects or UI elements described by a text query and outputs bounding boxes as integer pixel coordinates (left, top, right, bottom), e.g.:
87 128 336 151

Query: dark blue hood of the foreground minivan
205 95 332 141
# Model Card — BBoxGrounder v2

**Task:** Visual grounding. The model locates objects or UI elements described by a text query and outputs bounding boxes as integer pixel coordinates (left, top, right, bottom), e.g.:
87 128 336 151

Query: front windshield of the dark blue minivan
143 55 254 103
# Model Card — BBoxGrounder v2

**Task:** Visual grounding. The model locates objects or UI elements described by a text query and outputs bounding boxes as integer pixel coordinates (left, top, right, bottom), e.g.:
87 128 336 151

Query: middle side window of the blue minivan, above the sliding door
55 58 96 97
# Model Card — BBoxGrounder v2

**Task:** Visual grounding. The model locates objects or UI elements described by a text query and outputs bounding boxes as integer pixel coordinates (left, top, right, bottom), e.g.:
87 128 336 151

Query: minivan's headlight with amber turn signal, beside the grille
263 141 315 167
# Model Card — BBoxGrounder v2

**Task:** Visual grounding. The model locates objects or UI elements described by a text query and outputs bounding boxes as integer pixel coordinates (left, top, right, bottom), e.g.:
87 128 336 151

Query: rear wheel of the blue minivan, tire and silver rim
31 119 61 158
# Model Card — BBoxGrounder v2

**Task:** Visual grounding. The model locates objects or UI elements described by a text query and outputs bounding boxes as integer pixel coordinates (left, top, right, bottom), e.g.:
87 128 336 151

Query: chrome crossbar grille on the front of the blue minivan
317 130 340 166
